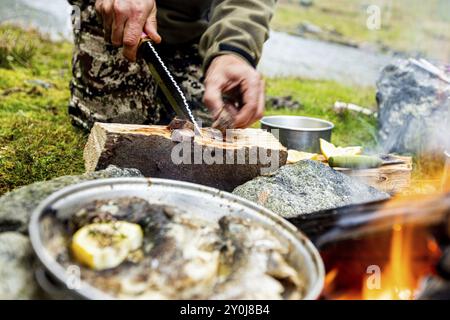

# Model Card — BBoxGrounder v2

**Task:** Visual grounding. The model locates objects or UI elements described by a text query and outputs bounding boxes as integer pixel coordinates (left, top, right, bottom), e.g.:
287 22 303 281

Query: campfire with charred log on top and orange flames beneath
293 190 450 300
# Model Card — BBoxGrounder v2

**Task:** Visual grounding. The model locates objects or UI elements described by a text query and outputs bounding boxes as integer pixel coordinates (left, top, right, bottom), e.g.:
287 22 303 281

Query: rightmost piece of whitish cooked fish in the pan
212 216 302 300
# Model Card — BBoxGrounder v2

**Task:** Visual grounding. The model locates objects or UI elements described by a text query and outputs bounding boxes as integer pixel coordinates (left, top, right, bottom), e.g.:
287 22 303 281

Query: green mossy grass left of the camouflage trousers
0 26 86 194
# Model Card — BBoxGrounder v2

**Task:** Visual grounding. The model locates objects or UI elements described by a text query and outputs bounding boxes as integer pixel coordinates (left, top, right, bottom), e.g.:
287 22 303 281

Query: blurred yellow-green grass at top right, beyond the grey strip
272 0 450 62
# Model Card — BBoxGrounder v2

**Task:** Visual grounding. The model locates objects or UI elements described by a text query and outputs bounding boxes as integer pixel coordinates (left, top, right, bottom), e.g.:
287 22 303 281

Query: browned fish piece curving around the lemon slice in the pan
70 198 220 299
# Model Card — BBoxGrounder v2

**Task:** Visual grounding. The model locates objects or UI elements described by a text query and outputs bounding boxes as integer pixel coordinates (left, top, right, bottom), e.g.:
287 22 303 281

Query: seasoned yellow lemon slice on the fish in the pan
71 221 144 270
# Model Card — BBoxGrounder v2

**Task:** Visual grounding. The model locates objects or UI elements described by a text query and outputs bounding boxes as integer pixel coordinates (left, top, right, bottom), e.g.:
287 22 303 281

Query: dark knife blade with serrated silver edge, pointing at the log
138 37 201 135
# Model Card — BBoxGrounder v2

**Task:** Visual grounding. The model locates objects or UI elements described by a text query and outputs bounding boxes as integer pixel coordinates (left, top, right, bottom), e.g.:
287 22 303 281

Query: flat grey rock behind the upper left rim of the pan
0 166 142 233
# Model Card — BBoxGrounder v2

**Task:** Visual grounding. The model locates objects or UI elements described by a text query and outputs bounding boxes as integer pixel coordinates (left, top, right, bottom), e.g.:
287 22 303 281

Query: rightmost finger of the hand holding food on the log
234 75 261 128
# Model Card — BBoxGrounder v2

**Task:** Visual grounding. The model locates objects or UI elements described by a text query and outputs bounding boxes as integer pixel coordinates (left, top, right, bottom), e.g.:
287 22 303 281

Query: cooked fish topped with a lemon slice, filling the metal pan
42 197 305 299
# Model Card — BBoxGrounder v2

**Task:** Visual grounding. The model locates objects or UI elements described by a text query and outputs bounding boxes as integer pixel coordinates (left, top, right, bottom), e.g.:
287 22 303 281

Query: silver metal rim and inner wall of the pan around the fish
29 178 325 299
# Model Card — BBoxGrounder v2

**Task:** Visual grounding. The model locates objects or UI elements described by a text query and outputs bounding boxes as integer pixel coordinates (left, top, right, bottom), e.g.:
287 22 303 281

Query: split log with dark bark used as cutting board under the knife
84 123 287 191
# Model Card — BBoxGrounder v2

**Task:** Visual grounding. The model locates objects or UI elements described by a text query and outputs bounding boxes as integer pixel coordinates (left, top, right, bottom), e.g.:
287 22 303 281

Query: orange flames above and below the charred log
323 155 450 300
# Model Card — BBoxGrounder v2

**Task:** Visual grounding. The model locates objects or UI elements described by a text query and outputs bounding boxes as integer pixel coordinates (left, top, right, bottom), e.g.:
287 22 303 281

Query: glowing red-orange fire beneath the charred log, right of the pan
322 220 440 300
